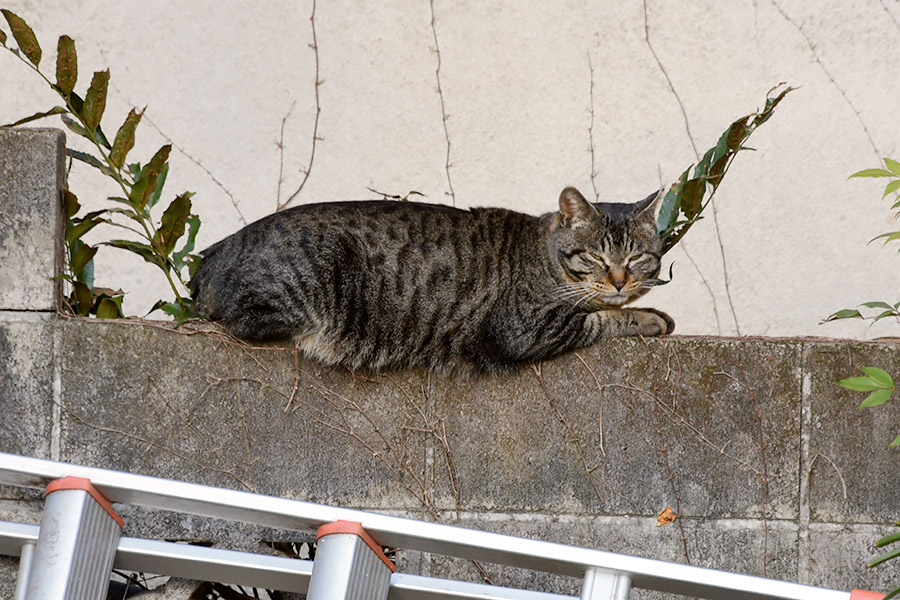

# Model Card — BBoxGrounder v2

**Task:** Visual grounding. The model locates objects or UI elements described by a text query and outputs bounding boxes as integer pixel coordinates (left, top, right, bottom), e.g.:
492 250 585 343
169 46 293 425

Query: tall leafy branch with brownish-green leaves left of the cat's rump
0 9 200 322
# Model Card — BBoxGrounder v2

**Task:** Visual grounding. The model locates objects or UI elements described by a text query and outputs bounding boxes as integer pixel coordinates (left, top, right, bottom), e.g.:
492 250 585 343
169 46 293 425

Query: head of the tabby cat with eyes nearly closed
550 187 662 310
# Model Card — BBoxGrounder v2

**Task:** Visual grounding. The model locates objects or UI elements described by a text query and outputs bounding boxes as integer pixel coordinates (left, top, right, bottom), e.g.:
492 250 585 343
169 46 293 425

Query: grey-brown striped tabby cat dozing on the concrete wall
190 187 675 373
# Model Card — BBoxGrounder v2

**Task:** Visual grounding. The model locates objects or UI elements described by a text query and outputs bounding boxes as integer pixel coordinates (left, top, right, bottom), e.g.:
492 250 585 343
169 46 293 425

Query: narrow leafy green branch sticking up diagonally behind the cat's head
656 84 794 254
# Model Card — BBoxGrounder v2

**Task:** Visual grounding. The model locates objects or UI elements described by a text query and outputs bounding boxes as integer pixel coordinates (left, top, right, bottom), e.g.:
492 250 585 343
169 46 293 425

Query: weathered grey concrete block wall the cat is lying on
0 131 900 599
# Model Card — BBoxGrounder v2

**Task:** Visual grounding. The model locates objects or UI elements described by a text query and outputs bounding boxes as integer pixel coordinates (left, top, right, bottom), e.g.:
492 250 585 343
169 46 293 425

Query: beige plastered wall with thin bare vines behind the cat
0 0 900 338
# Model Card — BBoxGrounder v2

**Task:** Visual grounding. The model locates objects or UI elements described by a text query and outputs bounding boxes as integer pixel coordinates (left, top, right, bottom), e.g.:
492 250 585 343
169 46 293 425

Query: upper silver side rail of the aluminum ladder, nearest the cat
0 453 850 600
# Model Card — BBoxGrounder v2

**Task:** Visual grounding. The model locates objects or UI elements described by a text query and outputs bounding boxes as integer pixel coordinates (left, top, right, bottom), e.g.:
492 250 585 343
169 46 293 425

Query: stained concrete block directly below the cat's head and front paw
435 339 800 519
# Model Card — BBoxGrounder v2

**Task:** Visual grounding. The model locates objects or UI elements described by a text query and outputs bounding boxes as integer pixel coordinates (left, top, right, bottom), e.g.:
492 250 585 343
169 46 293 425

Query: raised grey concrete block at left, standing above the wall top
0 129 66 311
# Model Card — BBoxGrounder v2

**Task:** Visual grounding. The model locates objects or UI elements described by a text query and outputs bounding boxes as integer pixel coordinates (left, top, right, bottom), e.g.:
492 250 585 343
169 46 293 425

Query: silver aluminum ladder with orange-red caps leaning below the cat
0 453 884 600
